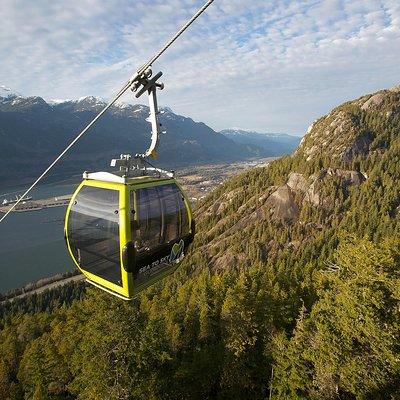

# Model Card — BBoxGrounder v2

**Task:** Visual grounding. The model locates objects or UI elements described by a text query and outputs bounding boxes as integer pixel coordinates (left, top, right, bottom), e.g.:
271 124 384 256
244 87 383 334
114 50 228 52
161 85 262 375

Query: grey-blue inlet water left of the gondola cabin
0 183 77 293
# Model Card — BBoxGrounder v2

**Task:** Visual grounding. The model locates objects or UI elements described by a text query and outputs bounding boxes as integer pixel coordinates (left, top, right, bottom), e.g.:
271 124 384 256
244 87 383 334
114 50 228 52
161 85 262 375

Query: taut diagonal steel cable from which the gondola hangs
0 0 214 223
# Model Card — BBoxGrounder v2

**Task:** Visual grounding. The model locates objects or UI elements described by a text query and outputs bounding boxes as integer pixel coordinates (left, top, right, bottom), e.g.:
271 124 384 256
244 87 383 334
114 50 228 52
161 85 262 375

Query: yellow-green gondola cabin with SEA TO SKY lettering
65 172 194 299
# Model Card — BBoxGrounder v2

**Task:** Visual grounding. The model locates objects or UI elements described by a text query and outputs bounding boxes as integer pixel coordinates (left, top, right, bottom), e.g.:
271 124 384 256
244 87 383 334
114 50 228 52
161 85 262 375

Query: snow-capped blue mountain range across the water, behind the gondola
0 86 297 186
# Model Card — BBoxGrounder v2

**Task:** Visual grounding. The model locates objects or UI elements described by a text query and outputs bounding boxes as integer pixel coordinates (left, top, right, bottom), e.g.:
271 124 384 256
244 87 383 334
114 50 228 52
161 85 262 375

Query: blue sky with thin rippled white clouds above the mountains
0 0 400 135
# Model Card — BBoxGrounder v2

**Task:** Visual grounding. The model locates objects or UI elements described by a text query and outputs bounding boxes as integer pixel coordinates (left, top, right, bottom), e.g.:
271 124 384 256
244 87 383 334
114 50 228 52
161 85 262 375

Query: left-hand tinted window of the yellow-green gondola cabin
68 186 121 285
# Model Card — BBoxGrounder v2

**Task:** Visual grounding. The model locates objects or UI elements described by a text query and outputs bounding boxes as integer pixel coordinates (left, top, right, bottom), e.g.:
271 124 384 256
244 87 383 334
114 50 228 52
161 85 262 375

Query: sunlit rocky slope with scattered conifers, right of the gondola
192 87 400 268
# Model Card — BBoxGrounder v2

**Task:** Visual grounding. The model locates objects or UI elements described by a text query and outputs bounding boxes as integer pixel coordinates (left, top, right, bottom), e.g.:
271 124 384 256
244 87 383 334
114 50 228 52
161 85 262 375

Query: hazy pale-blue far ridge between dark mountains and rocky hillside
220 128 301 157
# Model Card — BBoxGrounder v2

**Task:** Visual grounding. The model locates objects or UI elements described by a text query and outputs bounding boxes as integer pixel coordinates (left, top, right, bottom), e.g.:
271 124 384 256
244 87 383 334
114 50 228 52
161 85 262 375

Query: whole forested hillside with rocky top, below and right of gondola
0 87 400 400
